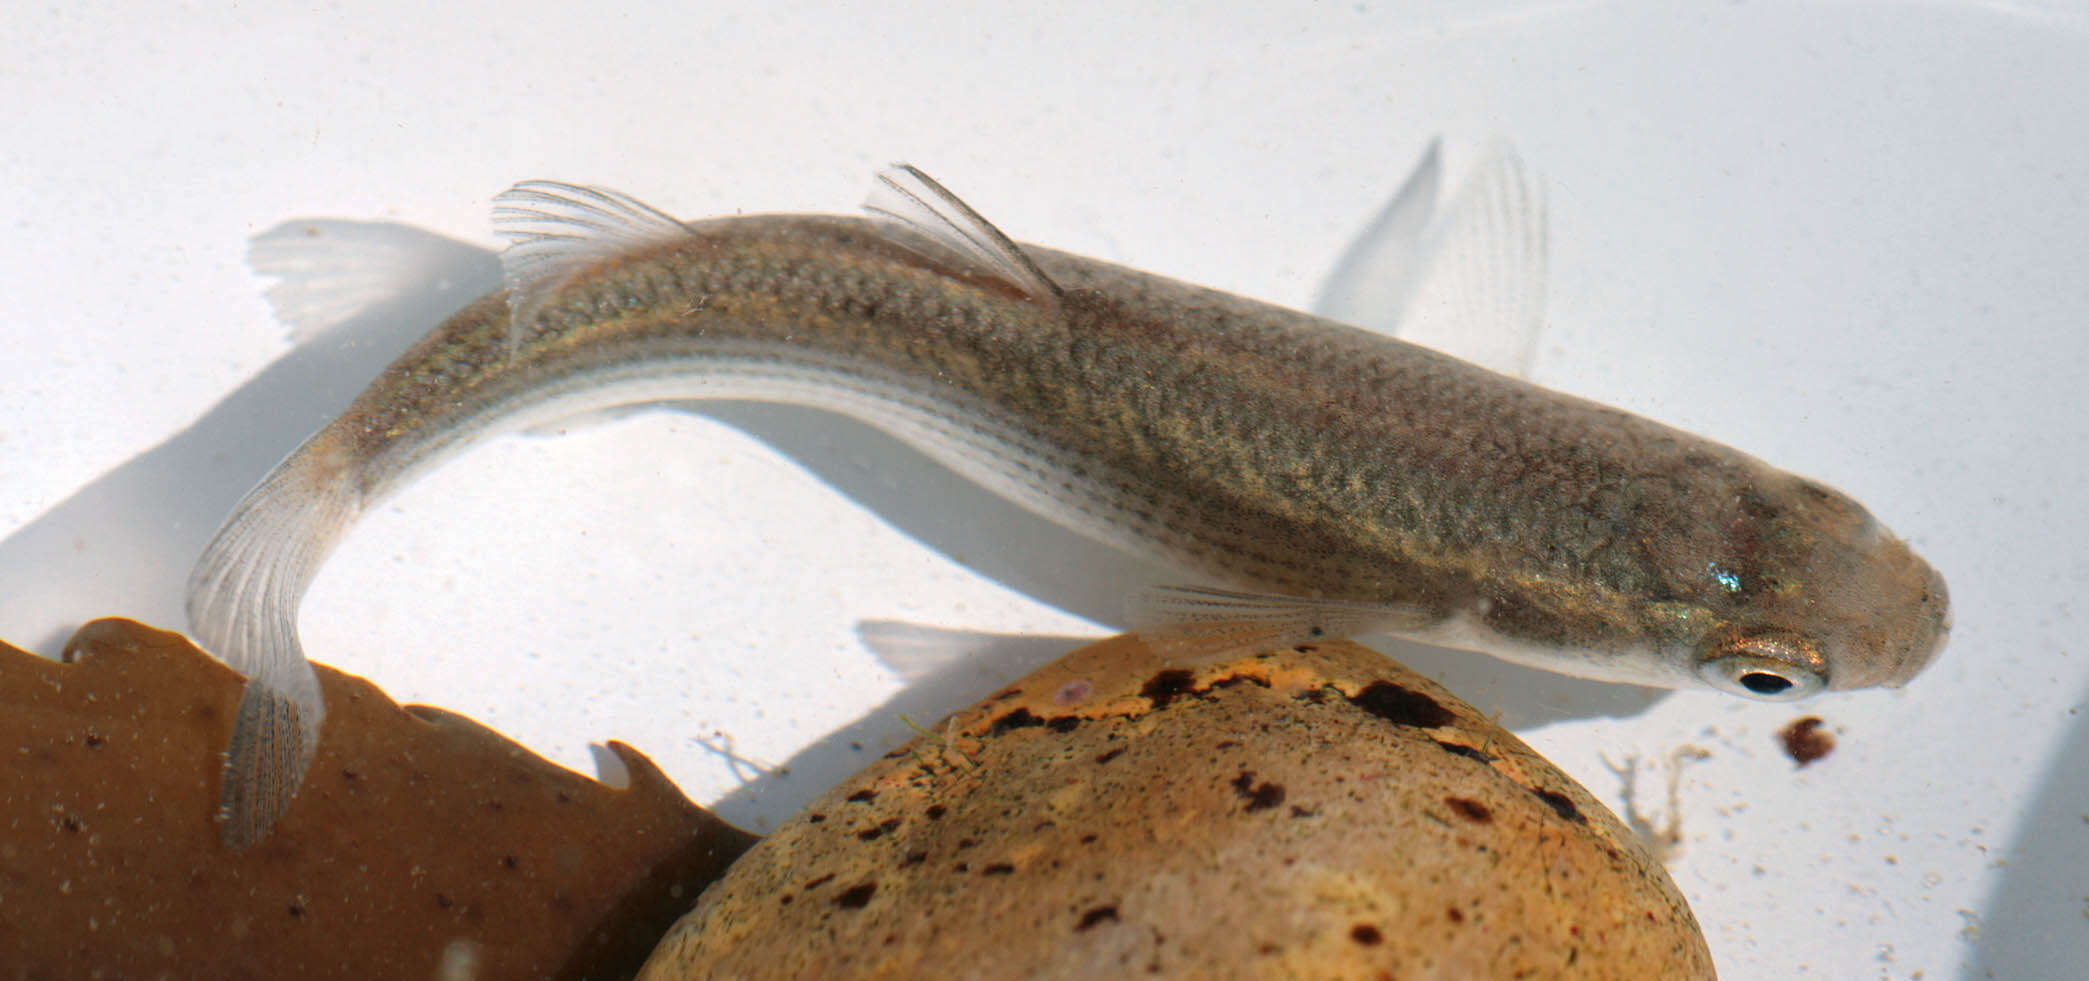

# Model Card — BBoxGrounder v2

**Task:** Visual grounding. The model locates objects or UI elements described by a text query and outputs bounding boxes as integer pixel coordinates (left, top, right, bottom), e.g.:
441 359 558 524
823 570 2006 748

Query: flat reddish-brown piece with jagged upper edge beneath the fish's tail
0 620 752 979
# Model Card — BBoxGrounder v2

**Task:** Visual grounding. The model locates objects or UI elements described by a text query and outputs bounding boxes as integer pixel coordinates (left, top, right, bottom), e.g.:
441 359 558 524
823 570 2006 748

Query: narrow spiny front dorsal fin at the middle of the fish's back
863 163 1059 303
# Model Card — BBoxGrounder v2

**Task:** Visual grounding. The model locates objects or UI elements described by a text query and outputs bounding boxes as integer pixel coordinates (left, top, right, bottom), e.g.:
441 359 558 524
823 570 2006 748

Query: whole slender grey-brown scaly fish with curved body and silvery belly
188 157 1947 847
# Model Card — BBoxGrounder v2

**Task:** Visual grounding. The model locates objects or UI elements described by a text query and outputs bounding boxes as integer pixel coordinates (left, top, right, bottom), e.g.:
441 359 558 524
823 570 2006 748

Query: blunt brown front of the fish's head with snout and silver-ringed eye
1692 474 1951 701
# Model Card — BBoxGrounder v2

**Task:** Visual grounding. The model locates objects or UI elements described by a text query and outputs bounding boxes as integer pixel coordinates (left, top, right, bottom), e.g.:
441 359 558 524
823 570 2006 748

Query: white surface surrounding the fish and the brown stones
0 0 2089 979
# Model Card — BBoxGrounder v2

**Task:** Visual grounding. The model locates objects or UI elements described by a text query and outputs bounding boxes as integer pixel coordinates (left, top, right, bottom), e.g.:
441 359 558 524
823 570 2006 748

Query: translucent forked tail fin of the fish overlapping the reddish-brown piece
188 432 355 850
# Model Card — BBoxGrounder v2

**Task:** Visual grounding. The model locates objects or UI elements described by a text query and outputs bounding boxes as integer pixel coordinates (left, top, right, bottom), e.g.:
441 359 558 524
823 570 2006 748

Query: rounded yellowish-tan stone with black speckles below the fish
641 637 1713 981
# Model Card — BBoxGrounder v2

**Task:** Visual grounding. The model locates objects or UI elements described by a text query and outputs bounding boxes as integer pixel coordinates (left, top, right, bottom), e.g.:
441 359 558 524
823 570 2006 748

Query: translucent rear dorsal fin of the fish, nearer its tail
493 180 689 353
